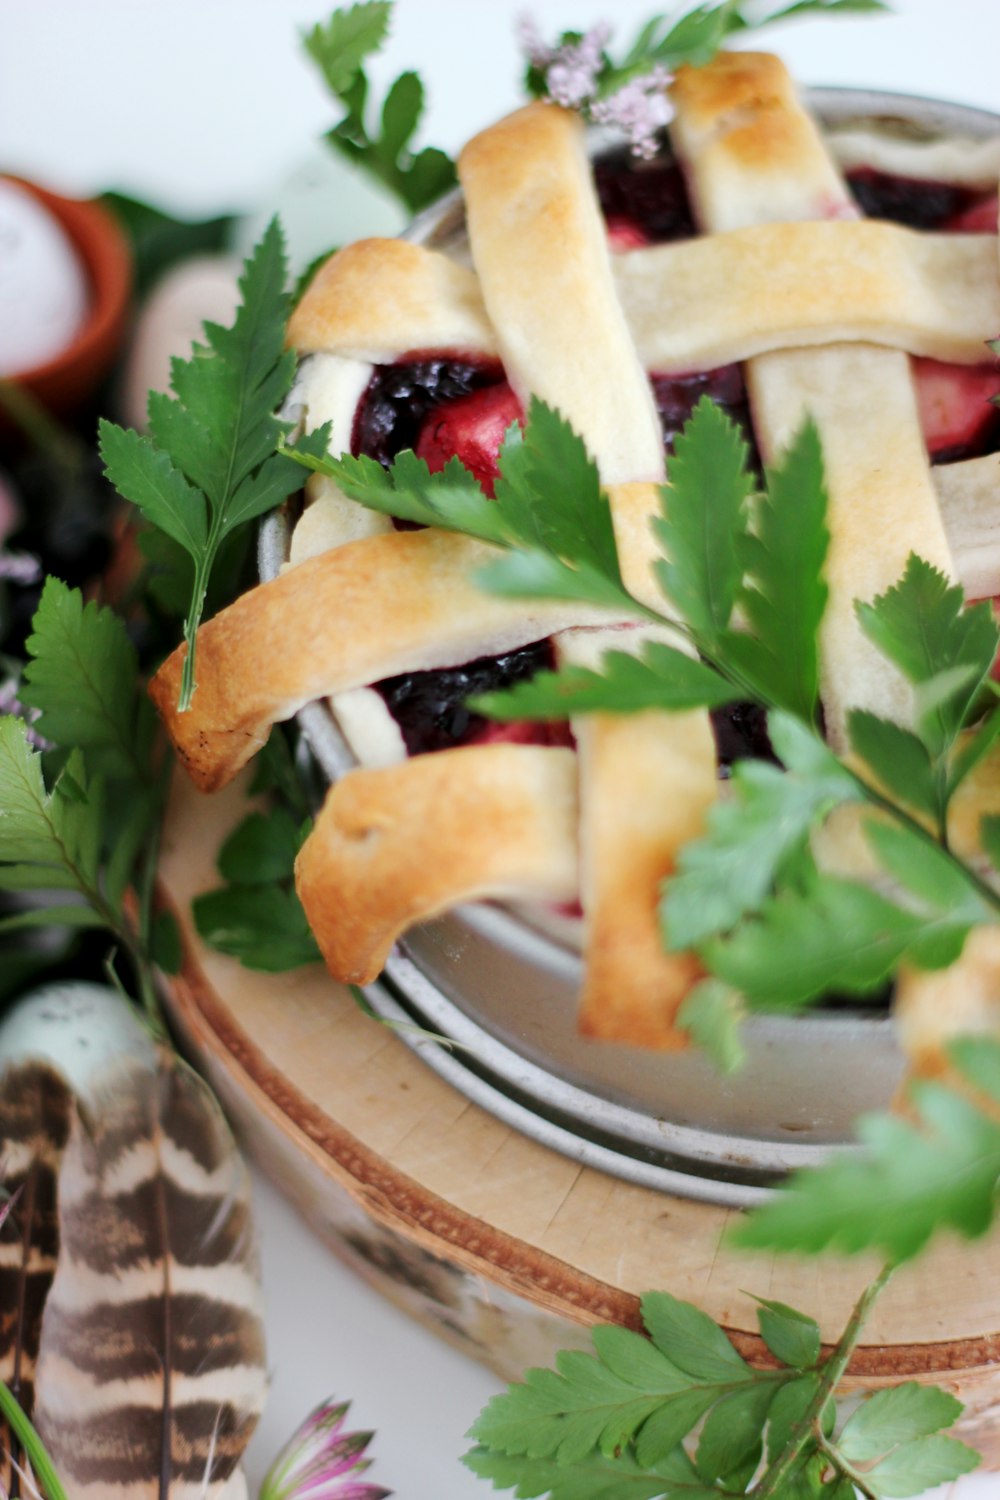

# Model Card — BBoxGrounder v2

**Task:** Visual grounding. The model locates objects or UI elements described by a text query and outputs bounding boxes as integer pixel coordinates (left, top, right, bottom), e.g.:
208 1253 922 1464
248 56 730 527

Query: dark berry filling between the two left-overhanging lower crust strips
375 641 570 755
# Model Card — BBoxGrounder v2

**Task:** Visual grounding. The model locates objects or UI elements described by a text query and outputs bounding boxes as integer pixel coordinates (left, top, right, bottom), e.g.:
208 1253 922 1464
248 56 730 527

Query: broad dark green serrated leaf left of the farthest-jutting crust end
22 578 150 780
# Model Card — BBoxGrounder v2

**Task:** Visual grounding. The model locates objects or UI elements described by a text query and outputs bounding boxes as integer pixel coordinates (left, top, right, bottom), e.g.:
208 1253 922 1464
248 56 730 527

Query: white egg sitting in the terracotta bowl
0 177 90 375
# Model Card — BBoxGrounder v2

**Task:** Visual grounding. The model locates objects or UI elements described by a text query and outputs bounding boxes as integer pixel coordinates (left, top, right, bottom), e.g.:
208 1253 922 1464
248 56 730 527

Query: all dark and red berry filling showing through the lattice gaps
351 150 1000 777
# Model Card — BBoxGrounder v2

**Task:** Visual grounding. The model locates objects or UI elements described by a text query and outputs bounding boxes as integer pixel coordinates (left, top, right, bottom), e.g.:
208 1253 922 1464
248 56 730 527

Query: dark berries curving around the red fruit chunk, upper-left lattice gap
351 353 504 468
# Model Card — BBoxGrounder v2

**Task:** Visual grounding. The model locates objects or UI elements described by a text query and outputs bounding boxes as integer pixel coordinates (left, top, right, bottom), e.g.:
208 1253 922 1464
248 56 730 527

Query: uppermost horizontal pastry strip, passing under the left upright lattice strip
284 228 1000 381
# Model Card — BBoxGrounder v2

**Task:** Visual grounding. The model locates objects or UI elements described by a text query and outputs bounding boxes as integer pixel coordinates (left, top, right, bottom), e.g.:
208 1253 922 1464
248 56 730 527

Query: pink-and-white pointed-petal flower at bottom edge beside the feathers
259 1401 391 1500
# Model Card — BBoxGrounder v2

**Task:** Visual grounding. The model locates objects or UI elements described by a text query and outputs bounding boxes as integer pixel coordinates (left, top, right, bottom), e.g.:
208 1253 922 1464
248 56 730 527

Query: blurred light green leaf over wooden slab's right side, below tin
730 1037 1000 1263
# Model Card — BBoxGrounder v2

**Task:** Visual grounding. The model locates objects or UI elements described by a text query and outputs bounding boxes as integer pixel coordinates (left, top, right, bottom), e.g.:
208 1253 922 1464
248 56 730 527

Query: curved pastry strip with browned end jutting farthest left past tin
150 528 614 792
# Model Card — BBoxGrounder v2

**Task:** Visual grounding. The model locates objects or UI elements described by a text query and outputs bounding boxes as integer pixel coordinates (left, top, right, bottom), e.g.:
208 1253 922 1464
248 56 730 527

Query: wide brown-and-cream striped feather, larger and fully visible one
34 1052 267 1500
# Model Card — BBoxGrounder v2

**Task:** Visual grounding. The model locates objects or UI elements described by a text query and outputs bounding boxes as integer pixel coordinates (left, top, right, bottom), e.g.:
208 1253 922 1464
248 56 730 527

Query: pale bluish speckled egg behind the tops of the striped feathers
0 980 156 1100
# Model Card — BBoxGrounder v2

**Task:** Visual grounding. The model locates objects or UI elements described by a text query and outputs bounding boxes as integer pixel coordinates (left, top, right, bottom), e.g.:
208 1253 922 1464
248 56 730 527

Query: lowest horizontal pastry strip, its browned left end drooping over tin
295 744 579 984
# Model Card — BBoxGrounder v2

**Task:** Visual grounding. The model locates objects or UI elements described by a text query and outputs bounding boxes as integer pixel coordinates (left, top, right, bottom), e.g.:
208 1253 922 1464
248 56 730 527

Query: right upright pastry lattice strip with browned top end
673 53 952 749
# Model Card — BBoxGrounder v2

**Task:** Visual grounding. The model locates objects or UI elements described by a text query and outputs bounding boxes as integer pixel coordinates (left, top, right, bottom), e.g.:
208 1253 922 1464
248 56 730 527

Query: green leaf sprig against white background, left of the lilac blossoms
306 0 456 213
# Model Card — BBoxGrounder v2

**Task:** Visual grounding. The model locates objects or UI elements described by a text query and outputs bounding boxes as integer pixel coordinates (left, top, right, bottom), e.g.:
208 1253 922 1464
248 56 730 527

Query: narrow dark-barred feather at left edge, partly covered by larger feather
0 1062 73 1497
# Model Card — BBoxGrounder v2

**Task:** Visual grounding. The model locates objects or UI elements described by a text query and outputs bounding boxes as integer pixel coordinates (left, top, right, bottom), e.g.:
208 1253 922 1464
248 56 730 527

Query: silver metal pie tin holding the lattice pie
259 89 1000 1206
